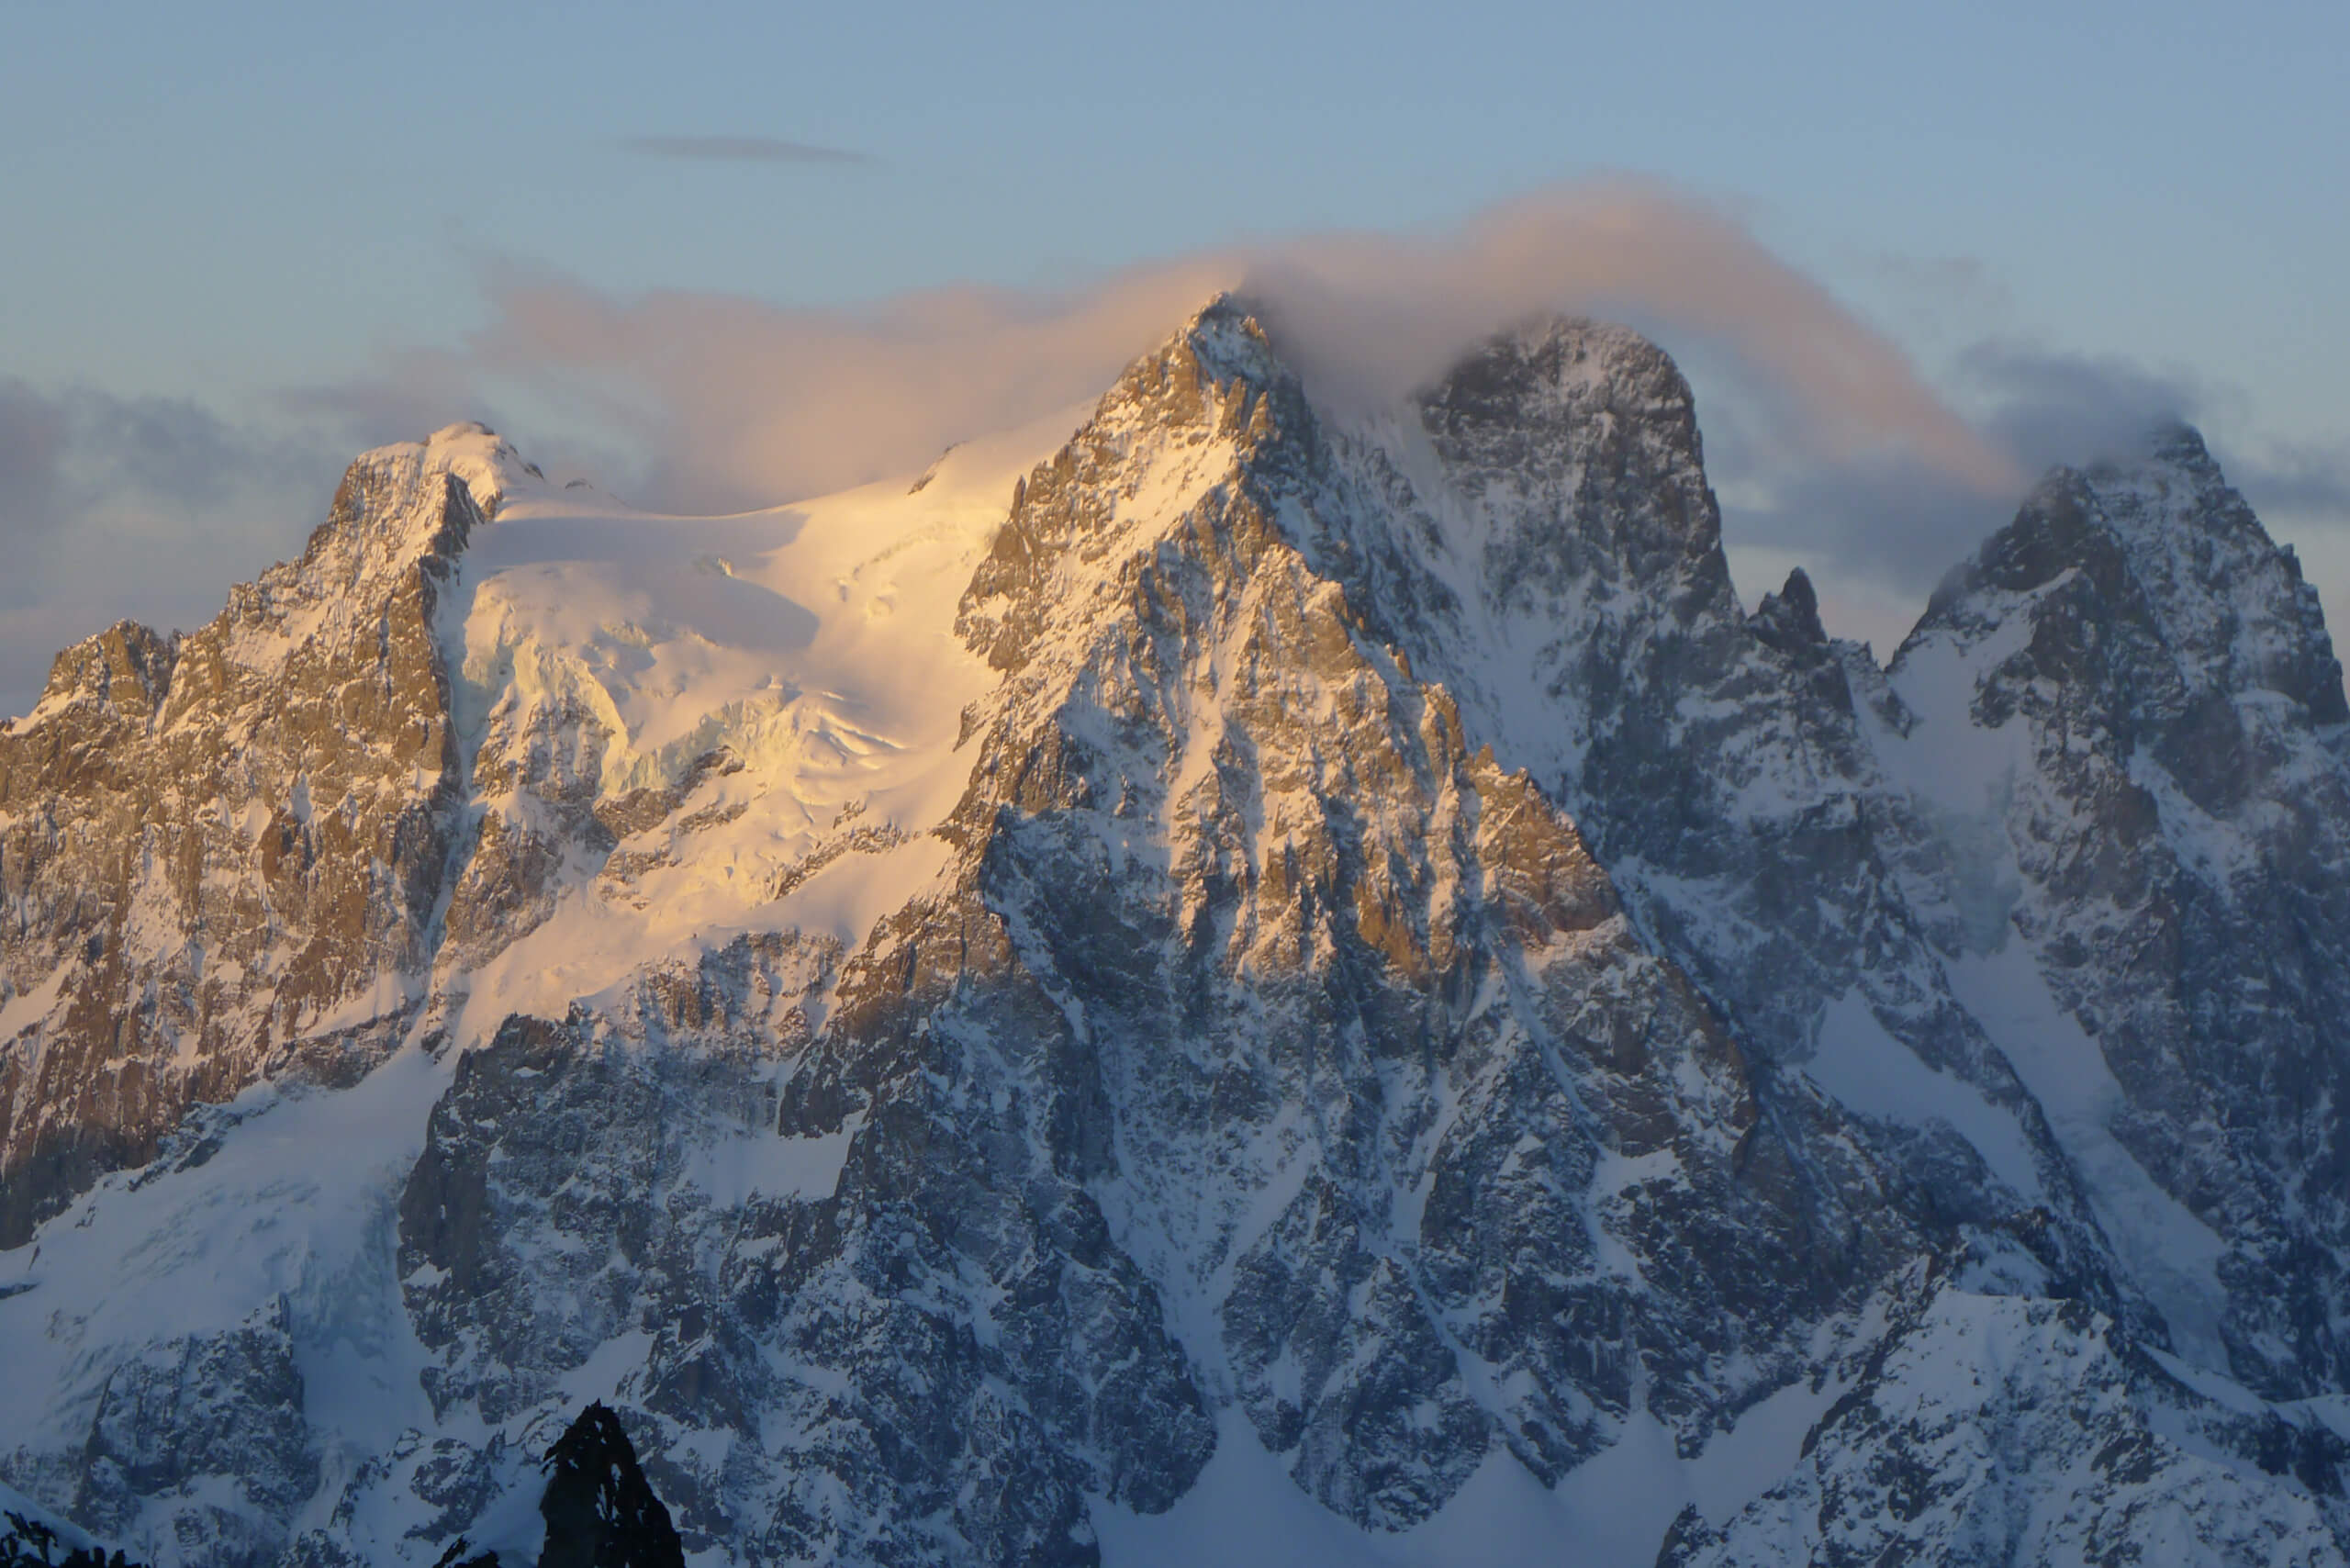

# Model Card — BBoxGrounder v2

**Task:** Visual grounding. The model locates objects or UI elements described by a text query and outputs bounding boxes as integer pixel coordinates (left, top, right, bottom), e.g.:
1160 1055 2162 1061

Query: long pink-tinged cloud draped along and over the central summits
350 184 2021 508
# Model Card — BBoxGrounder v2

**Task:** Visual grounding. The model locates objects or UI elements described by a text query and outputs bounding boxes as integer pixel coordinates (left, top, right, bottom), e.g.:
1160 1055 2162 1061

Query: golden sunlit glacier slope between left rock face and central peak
444 409 1081 1044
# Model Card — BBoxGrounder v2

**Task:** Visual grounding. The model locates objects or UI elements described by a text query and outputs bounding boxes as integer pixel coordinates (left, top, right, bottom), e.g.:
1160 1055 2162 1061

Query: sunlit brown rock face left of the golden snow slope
0 428 510 1246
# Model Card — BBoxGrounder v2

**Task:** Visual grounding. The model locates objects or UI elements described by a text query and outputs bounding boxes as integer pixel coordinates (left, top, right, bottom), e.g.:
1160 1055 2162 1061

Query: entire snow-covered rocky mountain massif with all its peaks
0 298 2350 1568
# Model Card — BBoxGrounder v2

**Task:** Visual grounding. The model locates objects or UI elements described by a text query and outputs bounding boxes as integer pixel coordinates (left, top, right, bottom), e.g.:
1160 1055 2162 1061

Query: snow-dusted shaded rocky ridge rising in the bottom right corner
1657 1288 2350 1568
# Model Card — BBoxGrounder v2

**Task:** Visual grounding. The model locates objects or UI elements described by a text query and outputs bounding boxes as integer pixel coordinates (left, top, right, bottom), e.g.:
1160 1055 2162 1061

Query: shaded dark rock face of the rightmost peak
1892 431 2350 1399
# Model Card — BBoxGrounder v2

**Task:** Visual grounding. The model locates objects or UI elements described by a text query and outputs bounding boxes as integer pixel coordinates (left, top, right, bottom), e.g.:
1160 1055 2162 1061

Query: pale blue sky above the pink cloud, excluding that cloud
0 0 2350 708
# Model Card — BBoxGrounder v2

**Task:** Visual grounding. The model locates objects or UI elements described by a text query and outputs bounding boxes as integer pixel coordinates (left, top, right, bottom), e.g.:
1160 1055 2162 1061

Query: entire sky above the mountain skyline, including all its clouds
0 0 2350 712
